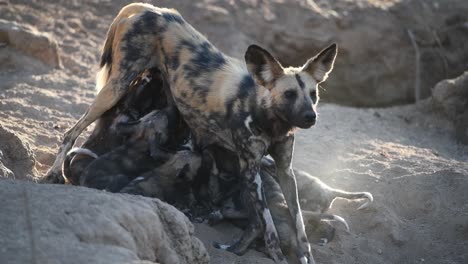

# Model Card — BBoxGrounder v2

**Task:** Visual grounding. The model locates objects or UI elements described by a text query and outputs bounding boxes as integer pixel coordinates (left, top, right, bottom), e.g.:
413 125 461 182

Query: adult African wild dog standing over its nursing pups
44 3 337 263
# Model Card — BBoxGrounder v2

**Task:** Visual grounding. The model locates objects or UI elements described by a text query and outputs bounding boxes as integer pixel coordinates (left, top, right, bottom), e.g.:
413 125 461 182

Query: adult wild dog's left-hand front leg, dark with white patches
218 134 286 263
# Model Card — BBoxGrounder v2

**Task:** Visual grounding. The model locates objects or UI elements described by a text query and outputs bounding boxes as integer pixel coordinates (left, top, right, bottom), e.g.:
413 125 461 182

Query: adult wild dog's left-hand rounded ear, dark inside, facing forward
245 45 283 88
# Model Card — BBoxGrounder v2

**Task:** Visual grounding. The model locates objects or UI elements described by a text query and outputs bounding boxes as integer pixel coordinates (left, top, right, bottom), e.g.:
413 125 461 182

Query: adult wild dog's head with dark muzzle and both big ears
245 44 338 128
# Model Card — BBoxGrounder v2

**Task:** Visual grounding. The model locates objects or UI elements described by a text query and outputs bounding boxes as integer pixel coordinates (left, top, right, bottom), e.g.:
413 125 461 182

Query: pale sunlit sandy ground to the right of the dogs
295 101 468 263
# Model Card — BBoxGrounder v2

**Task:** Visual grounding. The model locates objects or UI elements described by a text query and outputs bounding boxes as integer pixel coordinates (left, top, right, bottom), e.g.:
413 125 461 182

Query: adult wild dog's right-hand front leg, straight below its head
269 135 315 264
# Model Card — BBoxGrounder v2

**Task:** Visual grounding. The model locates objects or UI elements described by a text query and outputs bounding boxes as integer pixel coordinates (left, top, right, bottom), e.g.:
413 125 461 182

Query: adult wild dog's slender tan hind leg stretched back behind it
44 63 146 183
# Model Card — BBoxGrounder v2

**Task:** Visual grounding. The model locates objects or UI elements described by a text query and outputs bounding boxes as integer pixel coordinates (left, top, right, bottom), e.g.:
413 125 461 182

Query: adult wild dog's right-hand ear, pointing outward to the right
303 43 338 83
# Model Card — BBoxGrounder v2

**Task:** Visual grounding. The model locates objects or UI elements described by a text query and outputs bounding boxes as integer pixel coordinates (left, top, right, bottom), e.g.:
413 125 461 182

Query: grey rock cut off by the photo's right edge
432 71 468 144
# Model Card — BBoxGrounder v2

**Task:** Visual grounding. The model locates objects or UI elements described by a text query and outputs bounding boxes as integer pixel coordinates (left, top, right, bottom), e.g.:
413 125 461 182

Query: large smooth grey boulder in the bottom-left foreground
0 180 209 264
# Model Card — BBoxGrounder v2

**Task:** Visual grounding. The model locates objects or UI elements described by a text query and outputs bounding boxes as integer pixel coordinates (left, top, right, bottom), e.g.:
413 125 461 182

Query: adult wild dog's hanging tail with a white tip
96 3 151 93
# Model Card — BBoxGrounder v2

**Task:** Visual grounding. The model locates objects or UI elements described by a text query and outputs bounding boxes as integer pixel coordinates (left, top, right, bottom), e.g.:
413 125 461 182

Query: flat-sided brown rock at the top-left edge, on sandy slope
0 19 61 68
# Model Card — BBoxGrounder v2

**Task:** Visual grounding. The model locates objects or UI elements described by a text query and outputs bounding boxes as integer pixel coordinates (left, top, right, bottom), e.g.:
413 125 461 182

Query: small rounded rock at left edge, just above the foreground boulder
0 124 35 179
